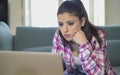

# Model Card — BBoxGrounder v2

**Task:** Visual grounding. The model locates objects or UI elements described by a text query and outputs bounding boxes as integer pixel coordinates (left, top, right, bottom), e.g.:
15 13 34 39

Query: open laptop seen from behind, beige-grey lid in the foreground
0 51 64 75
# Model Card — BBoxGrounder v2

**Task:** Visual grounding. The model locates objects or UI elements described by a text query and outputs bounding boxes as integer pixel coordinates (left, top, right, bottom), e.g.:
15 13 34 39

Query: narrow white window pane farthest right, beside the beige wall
93 0 105 26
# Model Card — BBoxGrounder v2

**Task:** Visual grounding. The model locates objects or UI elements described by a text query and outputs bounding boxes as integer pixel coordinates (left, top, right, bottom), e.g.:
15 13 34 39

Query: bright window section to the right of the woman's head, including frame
81 0 105 26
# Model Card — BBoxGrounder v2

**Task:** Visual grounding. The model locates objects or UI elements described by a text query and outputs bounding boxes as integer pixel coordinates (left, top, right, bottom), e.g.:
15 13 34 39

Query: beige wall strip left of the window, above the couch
9 0 24 34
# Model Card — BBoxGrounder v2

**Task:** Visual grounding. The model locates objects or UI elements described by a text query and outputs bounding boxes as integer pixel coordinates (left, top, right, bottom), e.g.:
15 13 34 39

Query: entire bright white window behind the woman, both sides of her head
25 0 105 27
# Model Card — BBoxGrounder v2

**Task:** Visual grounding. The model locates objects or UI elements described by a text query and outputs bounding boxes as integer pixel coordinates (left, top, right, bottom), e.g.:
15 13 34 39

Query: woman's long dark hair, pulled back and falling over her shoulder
57 0 102 46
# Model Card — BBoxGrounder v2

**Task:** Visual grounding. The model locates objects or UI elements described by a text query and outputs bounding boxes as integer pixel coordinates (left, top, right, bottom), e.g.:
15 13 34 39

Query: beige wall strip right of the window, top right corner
106 0 120 25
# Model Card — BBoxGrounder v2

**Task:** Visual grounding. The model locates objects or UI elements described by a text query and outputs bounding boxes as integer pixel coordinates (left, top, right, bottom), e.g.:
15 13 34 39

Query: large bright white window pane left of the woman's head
30 0 58 27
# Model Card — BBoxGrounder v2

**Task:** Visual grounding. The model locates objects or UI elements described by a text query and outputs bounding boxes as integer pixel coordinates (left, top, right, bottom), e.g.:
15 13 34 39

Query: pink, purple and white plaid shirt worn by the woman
52 29 116 75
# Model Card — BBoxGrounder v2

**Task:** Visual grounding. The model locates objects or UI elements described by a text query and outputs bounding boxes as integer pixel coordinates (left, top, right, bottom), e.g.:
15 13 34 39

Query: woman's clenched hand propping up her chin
73 30 88 45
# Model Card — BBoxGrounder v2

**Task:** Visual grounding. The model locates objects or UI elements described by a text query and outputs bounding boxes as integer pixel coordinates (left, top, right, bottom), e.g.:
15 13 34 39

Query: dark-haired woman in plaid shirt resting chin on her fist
52 0 115 75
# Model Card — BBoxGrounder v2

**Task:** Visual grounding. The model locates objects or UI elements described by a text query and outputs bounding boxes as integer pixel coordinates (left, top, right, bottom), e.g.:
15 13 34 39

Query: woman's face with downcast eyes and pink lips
58 12 85 41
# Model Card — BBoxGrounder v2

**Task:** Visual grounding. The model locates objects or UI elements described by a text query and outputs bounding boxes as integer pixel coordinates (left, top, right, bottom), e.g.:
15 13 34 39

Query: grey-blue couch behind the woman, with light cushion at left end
0 22 120 75
